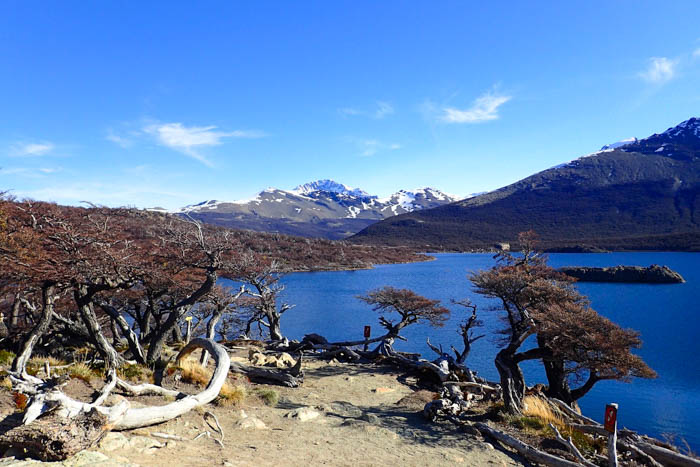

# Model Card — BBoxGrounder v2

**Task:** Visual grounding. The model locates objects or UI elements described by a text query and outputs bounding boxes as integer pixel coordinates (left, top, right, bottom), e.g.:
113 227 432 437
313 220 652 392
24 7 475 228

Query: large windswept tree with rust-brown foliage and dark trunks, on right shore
470 232 654 413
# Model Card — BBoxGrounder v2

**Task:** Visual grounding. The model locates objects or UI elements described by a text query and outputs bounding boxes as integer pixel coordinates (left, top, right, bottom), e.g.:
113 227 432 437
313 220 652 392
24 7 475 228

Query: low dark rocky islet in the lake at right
559 264 685 284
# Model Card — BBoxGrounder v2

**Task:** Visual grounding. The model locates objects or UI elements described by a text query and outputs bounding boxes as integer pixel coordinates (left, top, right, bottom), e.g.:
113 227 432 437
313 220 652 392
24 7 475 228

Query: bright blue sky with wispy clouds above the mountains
0 0 700 208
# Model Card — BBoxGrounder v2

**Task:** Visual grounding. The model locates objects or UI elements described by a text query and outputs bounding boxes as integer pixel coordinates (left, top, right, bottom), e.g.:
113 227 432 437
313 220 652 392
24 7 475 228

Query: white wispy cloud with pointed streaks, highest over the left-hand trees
143 123 265 167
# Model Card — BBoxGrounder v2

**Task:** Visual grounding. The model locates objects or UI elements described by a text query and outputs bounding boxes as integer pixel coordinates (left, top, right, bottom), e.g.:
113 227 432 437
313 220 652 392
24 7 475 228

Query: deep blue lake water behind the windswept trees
224 252 700 451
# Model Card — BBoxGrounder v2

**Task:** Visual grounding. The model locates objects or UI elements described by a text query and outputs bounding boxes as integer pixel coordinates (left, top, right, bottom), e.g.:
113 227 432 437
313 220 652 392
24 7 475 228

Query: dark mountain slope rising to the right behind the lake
351 118 700 254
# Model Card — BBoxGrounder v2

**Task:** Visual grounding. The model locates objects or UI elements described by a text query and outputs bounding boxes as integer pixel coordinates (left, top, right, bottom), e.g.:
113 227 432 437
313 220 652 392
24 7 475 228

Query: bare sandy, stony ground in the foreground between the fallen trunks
0 355 523 467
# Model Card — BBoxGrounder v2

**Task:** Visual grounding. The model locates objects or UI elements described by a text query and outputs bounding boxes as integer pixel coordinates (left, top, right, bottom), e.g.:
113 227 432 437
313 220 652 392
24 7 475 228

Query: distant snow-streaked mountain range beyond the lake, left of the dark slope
176 180 458 239
